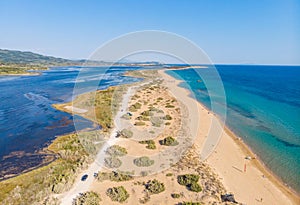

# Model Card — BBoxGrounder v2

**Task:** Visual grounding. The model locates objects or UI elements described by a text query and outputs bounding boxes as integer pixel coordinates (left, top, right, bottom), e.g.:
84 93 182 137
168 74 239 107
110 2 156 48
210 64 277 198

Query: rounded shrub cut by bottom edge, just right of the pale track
72 191 101 205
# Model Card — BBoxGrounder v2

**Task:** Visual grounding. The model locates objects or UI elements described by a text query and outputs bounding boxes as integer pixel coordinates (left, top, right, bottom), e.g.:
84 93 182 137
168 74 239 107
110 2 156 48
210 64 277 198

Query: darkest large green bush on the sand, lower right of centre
177 174 202 192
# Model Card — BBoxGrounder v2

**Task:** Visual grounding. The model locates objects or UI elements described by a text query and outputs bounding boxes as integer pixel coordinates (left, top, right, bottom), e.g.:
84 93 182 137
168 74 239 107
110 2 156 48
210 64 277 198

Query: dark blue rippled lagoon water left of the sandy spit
0 67 139 179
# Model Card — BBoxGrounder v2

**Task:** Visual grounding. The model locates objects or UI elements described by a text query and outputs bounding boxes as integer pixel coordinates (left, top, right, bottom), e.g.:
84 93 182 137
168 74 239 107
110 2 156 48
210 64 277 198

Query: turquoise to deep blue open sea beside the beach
168 65 300 192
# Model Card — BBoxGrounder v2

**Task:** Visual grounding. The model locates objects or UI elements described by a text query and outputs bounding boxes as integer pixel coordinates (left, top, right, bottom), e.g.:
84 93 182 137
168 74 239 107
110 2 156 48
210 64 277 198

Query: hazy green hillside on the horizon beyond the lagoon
0 49 80 65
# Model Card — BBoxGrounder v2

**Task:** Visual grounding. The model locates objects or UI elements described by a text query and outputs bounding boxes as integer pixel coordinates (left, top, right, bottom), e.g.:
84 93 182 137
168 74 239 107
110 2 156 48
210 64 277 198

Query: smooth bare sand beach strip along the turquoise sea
159 70 300 204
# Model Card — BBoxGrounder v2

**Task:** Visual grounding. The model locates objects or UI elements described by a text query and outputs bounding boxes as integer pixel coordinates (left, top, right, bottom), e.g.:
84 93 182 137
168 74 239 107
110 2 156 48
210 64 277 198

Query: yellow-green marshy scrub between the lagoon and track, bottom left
0 134 92 205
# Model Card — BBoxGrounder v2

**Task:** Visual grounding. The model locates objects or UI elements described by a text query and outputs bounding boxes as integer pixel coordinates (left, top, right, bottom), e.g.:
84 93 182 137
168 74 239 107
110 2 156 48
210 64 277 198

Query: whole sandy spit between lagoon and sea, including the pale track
58 70 299 205
